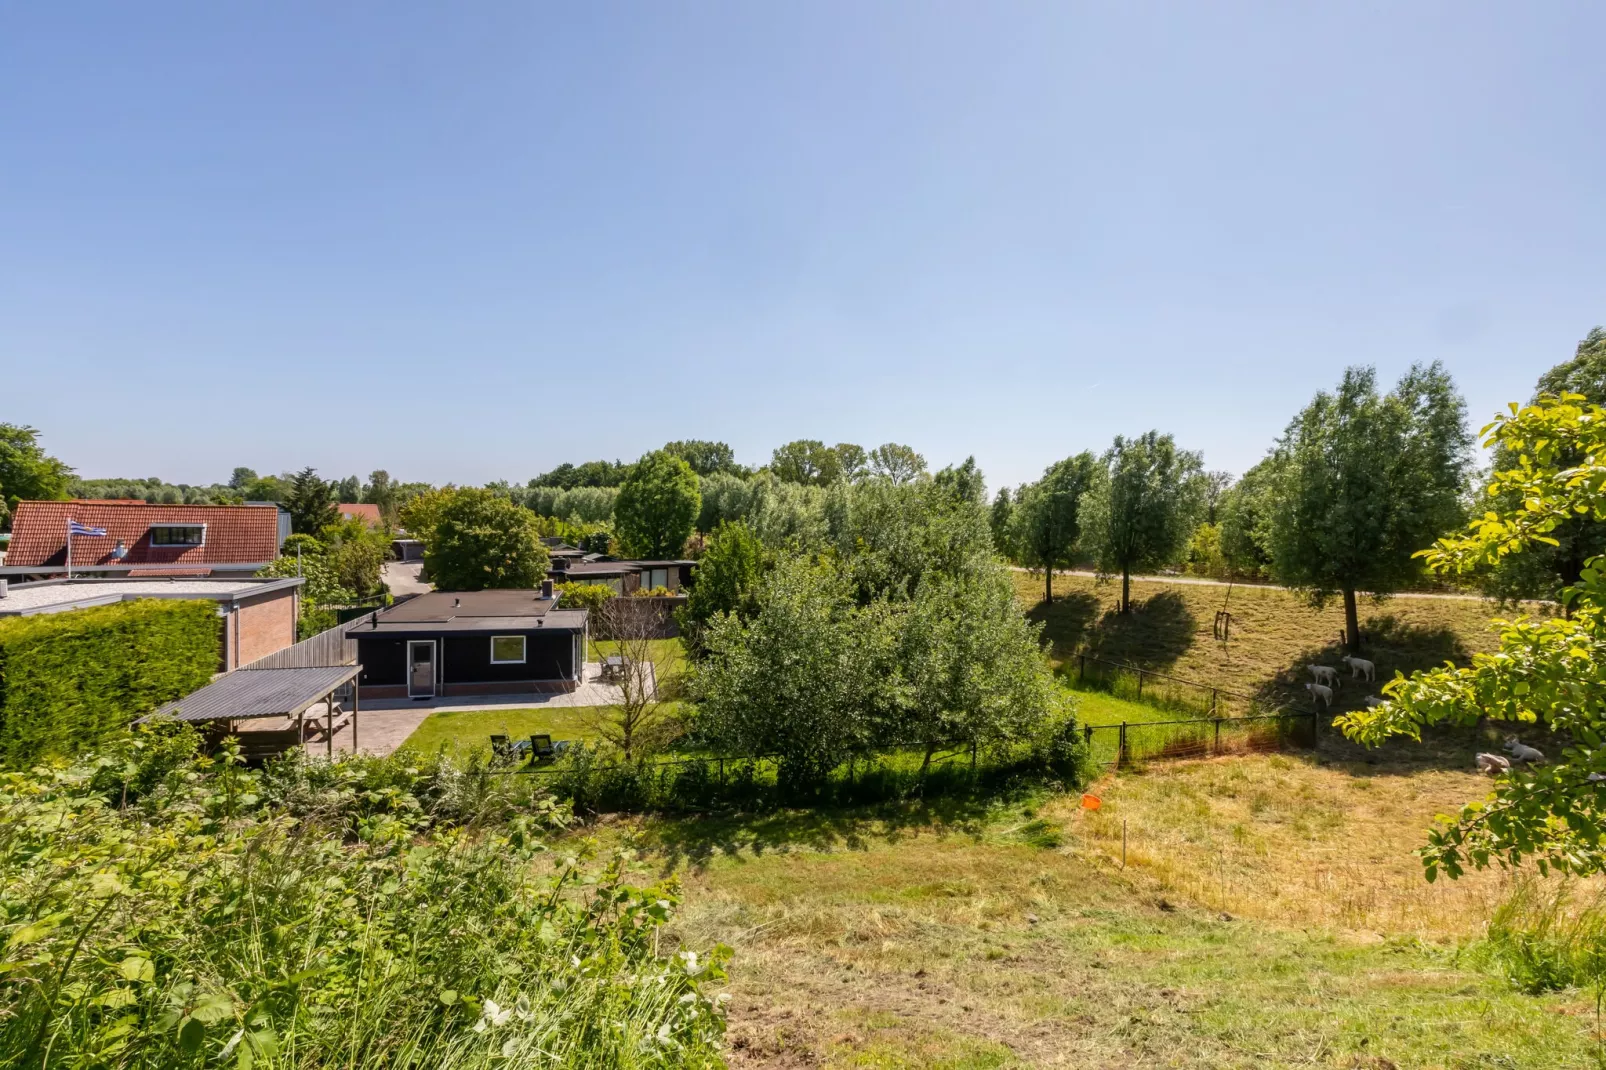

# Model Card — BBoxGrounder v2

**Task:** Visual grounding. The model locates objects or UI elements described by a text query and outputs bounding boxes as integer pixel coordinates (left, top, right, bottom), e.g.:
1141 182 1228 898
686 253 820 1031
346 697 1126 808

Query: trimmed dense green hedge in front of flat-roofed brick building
0 599 223 770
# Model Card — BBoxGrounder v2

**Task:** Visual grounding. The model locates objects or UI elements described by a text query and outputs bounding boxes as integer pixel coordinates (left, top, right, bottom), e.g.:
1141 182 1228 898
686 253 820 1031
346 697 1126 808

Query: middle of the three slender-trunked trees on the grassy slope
1082 431 1205 612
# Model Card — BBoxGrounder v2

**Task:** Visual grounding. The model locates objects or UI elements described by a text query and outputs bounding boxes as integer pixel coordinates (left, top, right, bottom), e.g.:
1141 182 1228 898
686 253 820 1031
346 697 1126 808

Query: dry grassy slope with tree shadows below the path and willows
1015 572 1547 710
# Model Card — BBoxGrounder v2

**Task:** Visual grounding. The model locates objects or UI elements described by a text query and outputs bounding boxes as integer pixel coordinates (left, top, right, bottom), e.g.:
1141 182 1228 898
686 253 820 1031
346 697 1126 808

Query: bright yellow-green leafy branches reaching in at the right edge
1338 394 1606 880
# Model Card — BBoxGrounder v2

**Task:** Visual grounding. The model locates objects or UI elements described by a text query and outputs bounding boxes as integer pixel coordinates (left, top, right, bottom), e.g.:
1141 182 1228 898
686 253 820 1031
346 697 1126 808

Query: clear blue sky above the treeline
0 0 1606 485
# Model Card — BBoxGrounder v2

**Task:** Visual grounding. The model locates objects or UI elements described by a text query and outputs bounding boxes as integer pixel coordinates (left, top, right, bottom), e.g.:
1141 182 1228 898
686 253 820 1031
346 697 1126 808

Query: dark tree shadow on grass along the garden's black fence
629 792 1017 874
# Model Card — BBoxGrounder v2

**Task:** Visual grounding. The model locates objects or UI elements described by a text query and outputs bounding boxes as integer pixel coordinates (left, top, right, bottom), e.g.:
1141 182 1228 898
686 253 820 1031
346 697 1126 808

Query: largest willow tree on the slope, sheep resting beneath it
1267 361 1471 652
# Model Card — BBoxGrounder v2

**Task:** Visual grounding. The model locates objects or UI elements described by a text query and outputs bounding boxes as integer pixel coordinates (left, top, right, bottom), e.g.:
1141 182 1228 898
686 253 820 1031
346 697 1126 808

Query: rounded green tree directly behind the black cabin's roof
423 487 549 591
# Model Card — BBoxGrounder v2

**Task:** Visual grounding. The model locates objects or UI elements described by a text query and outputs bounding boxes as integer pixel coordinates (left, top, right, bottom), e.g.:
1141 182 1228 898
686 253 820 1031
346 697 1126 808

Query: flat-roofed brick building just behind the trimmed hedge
0 577 304 672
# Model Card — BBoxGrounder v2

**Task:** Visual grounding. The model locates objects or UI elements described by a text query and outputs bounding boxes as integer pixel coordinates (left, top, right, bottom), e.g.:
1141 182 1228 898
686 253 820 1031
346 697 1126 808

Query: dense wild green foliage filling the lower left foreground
0 733 723 1068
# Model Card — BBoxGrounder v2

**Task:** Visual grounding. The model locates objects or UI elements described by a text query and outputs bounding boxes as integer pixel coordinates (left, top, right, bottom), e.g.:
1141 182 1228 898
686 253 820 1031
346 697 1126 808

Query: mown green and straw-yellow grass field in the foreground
604 744 1593 1070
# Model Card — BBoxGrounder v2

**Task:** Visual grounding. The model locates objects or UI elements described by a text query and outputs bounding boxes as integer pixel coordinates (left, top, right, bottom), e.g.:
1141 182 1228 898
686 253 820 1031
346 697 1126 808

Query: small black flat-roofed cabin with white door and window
345 585 588 699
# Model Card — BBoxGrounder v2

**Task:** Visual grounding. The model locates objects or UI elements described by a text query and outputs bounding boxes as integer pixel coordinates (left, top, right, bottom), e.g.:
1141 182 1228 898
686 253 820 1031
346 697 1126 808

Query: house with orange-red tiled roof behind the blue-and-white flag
0 500 289 578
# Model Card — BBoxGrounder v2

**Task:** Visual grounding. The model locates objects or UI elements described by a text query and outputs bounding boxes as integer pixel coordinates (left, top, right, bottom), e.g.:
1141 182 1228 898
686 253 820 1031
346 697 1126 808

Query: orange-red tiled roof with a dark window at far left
5 500 279 569
